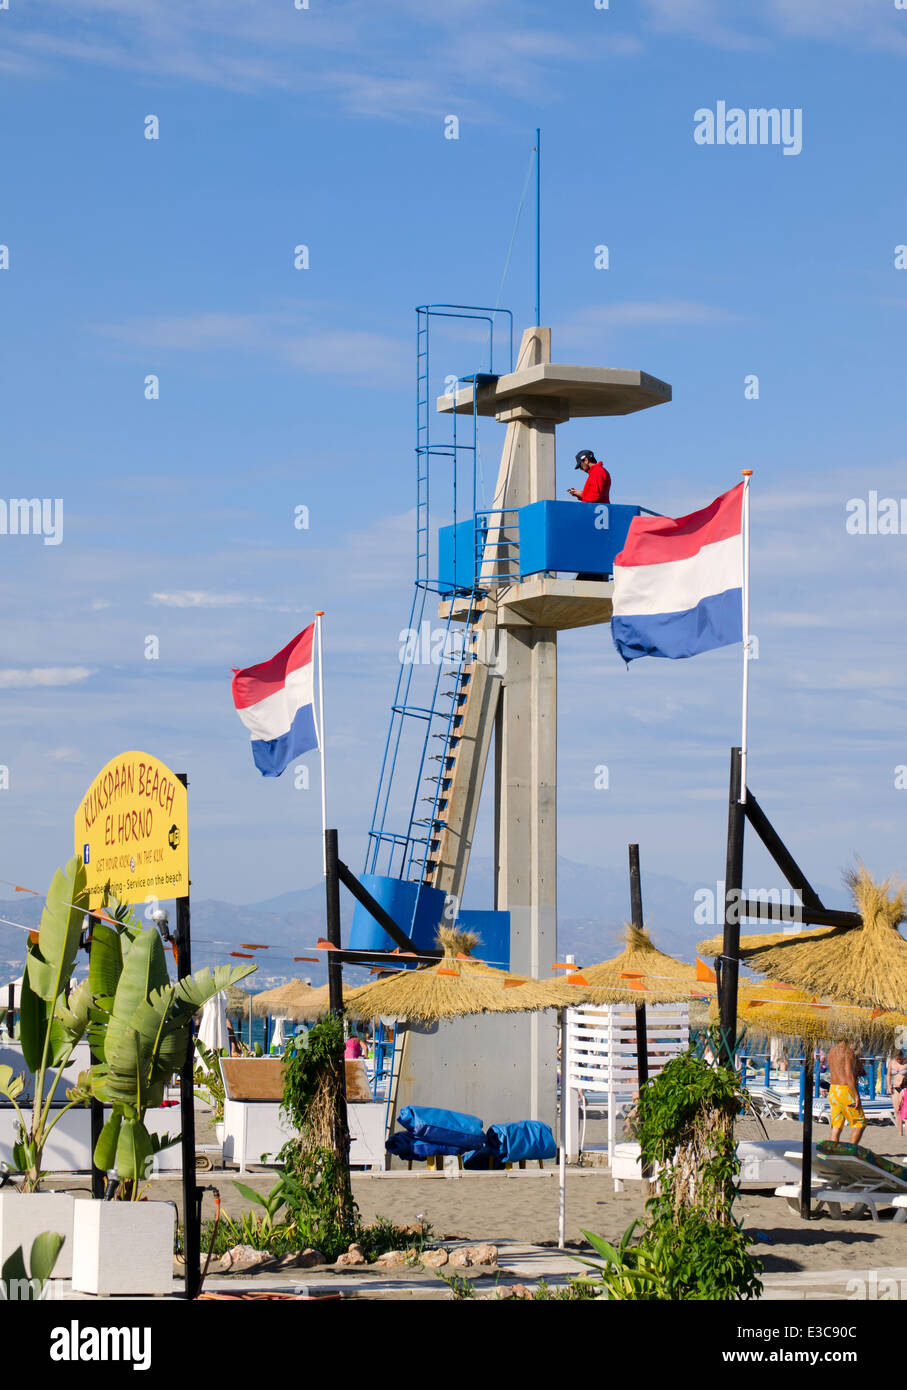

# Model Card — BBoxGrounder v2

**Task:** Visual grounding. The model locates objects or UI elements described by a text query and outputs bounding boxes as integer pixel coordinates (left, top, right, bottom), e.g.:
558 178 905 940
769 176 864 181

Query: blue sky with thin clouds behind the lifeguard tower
0 0 907 934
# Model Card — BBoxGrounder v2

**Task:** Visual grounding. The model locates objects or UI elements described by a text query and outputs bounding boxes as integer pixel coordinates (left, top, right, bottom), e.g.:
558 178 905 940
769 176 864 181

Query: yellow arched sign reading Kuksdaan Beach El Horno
75 752 189 908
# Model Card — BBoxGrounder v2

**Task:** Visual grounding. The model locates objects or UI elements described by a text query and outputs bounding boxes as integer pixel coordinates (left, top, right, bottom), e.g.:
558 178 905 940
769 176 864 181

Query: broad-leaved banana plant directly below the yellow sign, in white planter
85 904 256 1200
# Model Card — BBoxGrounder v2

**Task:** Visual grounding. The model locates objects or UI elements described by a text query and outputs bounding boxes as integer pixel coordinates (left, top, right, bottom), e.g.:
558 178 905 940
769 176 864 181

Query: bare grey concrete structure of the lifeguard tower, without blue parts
397 328 671 1126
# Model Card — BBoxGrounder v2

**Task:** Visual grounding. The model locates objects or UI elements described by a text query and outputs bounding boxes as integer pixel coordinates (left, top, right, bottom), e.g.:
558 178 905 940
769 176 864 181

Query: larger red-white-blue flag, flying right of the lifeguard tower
611 482 744 662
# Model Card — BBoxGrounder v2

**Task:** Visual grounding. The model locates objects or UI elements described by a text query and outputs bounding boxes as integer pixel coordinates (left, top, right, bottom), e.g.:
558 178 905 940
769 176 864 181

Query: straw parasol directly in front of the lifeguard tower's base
347 927 572 1023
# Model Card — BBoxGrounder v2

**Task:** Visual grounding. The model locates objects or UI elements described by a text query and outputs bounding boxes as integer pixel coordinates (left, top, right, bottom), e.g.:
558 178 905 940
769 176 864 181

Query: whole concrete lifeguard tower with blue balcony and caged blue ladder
350 306 671 1125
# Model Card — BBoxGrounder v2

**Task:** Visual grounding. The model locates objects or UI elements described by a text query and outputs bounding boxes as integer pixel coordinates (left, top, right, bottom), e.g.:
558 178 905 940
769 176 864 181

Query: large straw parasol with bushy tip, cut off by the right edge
697 865 907 1011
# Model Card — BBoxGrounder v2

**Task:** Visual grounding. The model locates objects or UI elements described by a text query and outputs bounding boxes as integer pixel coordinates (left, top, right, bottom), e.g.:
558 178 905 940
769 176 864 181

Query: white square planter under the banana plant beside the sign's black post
72 1201 176 1294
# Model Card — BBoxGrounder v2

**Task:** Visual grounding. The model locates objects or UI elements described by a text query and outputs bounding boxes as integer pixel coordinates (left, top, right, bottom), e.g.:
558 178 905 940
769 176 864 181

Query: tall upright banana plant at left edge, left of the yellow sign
0 855 90 1193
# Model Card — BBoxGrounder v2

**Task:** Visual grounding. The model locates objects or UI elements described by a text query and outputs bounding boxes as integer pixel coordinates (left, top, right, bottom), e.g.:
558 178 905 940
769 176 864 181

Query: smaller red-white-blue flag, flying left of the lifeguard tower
233 623 318 777
